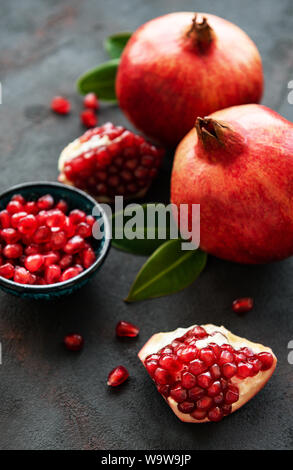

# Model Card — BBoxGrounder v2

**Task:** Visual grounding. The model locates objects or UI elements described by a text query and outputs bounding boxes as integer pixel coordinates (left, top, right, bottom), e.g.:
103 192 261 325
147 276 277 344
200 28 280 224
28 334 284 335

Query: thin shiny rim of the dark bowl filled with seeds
0 181 111 293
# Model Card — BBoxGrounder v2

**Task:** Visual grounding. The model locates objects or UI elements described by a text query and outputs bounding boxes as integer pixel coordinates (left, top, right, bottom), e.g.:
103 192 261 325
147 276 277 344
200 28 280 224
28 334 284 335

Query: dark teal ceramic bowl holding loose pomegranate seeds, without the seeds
0 182 111 299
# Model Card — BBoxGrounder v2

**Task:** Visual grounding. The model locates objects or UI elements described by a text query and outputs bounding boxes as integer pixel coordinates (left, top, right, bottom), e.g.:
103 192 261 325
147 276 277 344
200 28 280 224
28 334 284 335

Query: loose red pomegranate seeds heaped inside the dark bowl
0 194 96 285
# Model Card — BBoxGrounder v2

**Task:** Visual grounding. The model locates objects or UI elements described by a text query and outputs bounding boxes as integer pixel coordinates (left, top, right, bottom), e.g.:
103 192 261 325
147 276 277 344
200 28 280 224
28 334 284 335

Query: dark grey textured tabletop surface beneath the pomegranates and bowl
0 0 293 449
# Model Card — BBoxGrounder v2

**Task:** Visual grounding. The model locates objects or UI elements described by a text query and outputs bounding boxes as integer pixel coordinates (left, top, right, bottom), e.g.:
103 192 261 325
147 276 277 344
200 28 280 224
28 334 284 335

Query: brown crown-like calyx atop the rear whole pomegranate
186 13 215 53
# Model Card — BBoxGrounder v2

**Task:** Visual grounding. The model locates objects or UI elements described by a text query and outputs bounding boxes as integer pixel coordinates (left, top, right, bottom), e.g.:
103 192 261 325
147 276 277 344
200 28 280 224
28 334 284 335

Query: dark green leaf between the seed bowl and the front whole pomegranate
112 203 176 256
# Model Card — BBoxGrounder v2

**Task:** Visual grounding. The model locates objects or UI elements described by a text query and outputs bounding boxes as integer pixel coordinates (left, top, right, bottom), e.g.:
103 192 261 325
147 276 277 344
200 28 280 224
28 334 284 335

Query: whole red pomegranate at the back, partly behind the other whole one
116 12 263 146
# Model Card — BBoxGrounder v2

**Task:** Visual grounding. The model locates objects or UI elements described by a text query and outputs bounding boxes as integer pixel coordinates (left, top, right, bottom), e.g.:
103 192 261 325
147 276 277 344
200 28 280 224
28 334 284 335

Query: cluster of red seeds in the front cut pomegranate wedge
144 326 273 421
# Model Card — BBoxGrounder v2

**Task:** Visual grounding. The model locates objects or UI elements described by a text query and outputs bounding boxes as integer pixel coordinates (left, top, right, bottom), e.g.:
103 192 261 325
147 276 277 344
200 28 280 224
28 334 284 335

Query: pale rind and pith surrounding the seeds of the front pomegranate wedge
138 324 277 424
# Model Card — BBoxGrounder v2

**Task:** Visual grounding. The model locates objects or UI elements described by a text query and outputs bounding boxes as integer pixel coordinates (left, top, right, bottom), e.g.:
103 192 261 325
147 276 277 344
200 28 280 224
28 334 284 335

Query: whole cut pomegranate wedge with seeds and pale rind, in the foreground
138 325 277 423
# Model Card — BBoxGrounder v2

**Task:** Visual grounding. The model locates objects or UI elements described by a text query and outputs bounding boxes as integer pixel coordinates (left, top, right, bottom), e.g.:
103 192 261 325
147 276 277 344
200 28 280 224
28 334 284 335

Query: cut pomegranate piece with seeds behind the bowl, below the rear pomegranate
58 123 165 202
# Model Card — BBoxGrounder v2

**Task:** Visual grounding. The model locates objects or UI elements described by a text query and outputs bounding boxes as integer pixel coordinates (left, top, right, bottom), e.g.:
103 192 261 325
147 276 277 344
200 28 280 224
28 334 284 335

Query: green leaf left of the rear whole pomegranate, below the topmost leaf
77 59 119 102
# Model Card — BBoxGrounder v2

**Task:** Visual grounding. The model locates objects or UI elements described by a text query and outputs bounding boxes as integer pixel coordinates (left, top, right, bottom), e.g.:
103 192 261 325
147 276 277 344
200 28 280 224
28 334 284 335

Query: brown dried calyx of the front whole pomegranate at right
195 117 244 157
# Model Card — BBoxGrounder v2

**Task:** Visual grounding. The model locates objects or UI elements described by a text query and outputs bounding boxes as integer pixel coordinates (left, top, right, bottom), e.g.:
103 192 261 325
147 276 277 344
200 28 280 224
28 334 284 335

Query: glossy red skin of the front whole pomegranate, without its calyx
171 105 293 264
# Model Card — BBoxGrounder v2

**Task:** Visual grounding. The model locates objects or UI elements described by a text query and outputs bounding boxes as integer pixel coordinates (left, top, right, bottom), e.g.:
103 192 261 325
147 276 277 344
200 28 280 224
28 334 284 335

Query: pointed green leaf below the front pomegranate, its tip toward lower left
125 239 207 302
